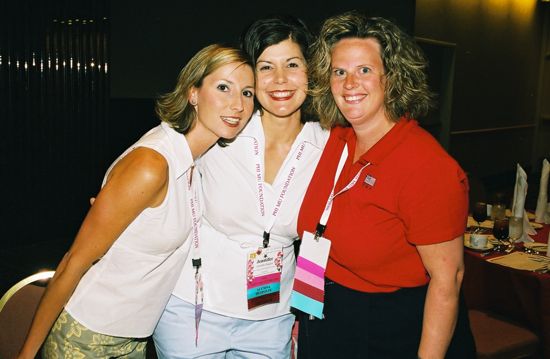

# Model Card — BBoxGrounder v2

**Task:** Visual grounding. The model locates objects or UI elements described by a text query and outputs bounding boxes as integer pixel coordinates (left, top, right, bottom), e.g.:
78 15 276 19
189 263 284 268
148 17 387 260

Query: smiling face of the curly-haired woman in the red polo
330 38 385 127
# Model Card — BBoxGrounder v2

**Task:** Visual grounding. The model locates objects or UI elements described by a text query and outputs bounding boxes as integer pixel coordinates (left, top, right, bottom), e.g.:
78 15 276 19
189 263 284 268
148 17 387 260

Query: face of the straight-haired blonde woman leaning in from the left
189 62 254 139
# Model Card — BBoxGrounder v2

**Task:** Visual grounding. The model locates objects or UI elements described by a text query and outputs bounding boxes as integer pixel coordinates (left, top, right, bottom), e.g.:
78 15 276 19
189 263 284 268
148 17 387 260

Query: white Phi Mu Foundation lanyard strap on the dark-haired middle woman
254 138 306 248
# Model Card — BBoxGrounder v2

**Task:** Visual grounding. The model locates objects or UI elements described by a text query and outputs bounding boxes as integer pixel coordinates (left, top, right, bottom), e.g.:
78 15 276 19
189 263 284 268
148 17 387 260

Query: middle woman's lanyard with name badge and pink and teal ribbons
246 139 305 310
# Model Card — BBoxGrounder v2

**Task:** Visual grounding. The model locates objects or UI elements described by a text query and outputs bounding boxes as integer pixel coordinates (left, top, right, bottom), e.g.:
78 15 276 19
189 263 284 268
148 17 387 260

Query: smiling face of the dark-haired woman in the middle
256 39 307 117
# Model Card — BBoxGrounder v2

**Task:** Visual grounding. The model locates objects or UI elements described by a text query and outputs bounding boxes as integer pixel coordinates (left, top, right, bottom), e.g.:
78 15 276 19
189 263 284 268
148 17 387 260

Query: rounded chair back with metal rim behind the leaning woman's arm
0 271 54 358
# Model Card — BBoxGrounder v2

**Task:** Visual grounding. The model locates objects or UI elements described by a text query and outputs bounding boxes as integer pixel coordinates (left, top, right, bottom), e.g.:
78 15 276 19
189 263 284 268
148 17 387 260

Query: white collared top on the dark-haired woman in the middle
173 112 329 320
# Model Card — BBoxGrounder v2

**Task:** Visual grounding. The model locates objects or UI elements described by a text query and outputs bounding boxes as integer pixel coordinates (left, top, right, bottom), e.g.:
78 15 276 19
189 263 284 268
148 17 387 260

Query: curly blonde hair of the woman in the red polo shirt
310 11 434 128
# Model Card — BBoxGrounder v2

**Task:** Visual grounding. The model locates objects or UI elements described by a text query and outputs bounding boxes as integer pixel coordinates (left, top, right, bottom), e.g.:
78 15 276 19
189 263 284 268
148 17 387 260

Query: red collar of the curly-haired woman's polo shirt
342 117 418 164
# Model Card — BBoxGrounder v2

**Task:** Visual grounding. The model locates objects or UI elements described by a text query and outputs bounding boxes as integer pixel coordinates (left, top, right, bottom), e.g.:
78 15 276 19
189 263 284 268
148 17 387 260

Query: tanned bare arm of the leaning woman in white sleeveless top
18 148 168 359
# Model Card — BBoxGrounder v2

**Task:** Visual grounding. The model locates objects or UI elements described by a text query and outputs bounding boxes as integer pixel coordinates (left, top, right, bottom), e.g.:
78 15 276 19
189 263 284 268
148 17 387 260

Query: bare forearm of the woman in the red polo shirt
417 236 464 359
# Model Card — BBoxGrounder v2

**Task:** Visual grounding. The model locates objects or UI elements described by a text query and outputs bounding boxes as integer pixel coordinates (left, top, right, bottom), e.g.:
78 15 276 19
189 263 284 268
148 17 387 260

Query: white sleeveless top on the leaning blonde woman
65 122 200 338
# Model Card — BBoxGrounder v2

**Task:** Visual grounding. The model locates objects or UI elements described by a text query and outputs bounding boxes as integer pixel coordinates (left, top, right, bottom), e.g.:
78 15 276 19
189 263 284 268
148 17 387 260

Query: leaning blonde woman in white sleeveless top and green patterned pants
18 45 254 359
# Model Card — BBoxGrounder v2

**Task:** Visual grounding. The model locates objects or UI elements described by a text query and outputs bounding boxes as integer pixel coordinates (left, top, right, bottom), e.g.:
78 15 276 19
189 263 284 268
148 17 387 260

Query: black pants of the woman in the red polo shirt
298 280 475 359
